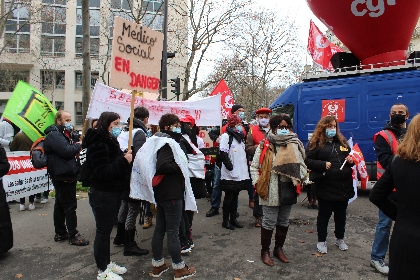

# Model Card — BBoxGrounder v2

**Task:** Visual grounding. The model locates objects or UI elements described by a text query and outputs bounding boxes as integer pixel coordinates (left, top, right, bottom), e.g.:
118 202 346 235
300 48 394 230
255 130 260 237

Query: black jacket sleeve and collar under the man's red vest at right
374 123 407 168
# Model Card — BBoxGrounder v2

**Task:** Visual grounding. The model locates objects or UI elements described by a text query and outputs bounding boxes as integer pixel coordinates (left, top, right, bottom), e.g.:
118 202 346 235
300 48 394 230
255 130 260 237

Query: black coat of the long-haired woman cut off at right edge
369 157 420 280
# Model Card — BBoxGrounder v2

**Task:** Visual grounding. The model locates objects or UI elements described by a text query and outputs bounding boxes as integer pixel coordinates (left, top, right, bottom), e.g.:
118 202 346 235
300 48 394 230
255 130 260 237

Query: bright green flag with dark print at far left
3 81 57 141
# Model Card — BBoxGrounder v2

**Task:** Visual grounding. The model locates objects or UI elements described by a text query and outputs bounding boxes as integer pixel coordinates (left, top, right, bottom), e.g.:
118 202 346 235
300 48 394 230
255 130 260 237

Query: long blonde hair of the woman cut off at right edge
397 115 420 161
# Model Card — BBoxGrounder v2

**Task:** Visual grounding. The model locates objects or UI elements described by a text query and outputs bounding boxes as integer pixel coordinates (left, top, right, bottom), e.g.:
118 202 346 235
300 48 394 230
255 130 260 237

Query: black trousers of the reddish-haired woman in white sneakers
317 198 348 242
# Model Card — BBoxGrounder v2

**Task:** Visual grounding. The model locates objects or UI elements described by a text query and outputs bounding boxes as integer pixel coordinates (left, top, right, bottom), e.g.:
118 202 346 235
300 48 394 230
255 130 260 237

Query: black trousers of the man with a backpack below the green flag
53 180 78 237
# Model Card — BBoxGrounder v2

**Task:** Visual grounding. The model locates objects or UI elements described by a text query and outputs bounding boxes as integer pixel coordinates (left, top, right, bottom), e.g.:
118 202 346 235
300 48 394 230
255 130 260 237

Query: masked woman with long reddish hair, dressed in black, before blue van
305 116 354 254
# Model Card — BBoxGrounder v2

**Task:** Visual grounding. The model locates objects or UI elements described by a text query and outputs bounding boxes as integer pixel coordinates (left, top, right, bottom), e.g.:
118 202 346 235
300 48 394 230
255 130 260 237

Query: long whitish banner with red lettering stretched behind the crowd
86 83 222 126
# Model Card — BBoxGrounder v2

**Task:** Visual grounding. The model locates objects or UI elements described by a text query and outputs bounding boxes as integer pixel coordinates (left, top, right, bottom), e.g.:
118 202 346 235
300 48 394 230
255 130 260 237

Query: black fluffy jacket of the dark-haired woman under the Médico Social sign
83 129 131 192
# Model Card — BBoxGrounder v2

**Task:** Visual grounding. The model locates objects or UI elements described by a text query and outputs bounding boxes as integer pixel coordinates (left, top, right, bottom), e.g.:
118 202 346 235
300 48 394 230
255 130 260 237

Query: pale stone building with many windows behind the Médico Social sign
0 0 188 128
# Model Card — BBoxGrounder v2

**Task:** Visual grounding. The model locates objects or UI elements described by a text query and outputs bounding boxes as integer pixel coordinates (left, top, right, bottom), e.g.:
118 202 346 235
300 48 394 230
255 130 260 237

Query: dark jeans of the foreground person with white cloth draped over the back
152 199 182 264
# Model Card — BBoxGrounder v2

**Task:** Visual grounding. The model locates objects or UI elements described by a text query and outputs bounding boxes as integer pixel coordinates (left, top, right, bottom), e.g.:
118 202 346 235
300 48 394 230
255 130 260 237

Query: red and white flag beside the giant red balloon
308 20 344 70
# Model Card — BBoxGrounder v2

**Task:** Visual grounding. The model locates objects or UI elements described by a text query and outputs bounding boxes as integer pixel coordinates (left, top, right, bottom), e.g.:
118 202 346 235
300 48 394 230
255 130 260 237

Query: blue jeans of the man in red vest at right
370 210 392 261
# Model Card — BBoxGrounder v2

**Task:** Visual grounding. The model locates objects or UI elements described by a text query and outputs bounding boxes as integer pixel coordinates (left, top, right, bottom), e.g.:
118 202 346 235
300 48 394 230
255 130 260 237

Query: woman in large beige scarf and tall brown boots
250 115 307 266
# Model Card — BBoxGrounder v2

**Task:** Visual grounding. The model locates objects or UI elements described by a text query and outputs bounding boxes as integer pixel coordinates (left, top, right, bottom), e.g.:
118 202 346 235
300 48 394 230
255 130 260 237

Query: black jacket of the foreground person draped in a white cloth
153 131 185 203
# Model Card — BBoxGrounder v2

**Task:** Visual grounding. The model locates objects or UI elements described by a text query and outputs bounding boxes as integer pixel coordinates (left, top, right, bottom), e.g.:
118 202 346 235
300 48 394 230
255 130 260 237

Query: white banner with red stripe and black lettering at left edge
3 151 54 201
